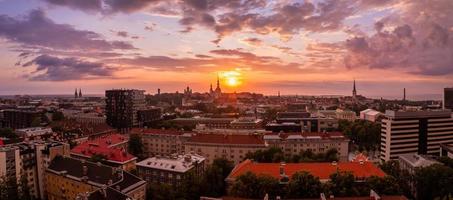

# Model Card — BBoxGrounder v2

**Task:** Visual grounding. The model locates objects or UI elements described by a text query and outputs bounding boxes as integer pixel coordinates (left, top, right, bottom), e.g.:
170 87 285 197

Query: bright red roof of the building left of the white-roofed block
71 134 136 163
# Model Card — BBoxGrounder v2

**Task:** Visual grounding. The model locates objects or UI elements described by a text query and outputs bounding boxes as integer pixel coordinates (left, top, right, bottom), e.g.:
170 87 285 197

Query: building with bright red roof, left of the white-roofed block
71 134 137 171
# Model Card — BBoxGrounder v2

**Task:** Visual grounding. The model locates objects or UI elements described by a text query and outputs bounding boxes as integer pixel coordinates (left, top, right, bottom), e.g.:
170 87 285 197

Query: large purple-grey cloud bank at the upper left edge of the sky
0 10 134 51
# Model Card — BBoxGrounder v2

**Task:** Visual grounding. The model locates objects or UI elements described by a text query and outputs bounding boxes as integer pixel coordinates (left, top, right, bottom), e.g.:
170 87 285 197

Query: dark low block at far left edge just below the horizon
3 109 41 129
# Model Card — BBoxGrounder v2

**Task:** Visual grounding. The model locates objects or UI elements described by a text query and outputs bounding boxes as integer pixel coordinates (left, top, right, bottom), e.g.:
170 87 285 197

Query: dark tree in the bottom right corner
414 164 453 199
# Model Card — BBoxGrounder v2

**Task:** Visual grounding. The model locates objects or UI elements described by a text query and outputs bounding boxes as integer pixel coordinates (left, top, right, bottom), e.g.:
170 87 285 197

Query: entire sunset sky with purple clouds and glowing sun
0 0 453 99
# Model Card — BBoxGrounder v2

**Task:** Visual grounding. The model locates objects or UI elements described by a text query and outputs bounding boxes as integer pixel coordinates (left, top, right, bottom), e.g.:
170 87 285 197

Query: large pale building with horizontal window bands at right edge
380 110 453 161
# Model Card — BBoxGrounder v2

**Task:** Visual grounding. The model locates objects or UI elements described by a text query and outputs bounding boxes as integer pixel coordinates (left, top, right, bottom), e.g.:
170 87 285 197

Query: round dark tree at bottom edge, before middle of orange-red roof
288 172 322 198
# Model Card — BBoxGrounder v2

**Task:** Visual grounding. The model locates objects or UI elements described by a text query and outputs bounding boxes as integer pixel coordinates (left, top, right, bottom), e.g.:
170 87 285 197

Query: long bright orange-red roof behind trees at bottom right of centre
228 160 385 180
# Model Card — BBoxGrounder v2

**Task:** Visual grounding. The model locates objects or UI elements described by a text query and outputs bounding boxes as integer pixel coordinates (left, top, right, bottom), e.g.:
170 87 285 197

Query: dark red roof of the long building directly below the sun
188 134 264 145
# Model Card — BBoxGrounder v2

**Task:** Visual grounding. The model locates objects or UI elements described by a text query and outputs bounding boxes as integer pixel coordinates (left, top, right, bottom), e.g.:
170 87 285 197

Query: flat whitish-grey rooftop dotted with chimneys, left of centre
136 154 205 173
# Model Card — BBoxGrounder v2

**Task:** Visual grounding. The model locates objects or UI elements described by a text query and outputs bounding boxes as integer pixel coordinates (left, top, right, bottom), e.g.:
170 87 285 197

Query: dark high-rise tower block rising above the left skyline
105 89 145 131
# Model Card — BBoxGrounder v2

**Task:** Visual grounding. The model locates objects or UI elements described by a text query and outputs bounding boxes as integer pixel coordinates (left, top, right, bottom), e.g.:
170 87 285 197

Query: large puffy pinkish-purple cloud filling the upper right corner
345 0 453 75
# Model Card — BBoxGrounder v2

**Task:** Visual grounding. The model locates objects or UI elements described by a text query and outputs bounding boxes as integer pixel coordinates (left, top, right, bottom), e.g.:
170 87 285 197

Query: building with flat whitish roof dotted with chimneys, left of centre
137 154 205 186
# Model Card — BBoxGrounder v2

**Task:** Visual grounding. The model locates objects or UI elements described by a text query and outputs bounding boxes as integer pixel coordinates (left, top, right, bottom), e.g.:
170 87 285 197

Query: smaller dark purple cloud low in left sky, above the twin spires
22 55 113 81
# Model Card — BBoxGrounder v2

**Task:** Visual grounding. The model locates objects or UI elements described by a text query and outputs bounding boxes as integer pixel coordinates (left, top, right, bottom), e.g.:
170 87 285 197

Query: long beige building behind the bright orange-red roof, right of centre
264 132 349 161
